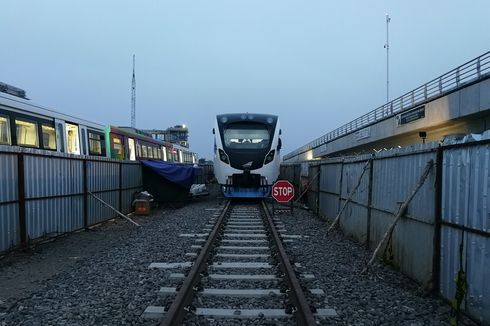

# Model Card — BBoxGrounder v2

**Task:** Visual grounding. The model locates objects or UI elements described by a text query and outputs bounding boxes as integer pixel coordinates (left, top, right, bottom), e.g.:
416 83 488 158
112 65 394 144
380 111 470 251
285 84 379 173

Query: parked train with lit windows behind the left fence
0 93 197 163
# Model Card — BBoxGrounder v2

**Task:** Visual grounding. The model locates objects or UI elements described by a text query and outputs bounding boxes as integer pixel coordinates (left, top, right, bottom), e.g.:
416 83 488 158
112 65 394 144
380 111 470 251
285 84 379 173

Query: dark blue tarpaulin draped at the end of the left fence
141 160 199 189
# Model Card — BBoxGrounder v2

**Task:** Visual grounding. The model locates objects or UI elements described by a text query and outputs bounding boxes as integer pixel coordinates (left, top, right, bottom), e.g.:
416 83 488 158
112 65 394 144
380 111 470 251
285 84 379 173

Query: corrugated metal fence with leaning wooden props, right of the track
281 141 490 325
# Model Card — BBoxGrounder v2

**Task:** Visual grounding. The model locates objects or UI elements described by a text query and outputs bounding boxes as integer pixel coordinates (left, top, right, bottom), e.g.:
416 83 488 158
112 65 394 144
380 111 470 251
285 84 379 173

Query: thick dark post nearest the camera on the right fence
432 146 444 291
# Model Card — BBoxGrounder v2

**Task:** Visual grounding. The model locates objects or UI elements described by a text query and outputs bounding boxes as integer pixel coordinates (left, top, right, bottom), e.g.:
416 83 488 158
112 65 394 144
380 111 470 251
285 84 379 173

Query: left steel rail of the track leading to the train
159 201 230 326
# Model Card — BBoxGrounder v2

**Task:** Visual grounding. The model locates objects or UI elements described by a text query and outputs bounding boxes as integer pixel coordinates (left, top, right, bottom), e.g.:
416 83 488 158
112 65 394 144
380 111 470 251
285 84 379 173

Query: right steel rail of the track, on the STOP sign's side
262 201 316 325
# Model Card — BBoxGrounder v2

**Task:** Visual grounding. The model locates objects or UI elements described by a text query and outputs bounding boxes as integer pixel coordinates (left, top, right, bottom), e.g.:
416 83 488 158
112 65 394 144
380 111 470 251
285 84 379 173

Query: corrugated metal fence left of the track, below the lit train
0 146 143 252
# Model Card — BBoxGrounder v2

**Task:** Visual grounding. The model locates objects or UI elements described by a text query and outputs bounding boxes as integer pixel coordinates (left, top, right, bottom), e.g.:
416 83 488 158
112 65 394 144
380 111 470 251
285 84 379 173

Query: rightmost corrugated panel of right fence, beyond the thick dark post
440 144 490 321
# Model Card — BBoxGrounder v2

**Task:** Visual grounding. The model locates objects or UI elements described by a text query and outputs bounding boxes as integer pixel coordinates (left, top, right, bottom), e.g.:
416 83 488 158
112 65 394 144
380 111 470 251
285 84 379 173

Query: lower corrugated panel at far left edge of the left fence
0 203 20 252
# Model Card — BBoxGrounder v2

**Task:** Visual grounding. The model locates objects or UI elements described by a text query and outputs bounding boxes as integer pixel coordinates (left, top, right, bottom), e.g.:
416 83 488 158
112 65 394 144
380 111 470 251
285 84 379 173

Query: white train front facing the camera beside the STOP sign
213 113 282 198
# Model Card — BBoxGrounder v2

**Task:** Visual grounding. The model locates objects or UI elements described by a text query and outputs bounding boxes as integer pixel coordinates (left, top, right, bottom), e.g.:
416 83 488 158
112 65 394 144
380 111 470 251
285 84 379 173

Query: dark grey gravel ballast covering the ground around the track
0 196 475 326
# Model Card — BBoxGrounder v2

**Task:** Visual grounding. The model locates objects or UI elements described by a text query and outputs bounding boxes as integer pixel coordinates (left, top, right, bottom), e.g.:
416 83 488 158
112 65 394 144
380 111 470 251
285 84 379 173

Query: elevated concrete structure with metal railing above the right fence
283 51 490 163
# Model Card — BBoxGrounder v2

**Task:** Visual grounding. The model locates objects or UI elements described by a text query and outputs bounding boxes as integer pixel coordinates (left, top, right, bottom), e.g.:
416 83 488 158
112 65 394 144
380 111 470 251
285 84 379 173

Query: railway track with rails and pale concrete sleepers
144 202 336 325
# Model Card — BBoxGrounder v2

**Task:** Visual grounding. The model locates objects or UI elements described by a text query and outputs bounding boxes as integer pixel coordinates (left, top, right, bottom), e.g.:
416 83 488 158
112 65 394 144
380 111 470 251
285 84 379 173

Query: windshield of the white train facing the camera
223 124 270 149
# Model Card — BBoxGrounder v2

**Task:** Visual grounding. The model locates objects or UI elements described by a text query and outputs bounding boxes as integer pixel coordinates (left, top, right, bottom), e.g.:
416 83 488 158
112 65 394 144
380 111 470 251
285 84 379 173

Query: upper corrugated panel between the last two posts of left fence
87 161 120 192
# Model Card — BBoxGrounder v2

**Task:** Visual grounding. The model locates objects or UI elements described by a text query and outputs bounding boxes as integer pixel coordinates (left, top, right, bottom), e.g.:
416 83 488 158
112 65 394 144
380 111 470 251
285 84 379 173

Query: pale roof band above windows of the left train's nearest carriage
0 93 104 130
